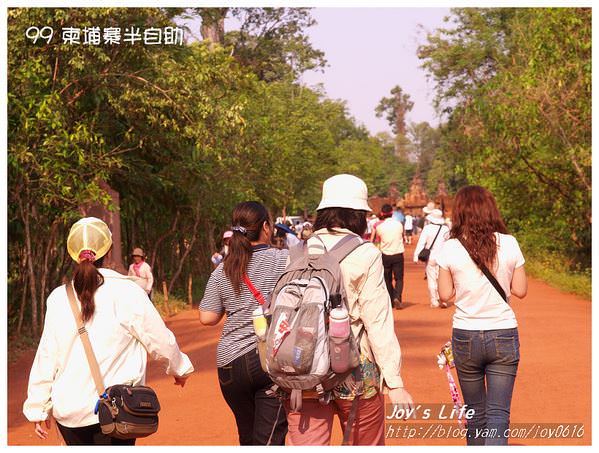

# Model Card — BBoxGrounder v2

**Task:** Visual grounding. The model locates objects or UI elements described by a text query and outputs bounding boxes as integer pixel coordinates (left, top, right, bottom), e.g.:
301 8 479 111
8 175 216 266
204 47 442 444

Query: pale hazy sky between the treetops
178 7 449 134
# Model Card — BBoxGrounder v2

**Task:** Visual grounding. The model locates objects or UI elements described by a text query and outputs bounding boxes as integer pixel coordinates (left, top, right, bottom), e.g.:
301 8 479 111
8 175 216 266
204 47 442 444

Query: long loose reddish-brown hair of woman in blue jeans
450 186 508 269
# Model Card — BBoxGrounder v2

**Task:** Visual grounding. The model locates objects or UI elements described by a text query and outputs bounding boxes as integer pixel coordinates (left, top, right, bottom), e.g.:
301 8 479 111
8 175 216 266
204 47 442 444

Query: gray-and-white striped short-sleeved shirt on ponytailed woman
200 245 289 367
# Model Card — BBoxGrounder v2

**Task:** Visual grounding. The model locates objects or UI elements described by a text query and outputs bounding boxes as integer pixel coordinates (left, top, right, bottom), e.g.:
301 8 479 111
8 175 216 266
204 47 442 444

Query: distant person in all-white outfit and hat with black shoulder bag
414 209 449 308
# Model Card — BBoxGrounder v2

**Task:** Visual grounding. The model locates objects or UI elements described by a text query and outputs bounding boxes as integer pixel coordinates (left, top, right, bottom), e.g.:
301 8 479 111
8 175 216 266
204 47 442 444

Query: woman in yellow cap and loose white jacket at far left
23 217 194 445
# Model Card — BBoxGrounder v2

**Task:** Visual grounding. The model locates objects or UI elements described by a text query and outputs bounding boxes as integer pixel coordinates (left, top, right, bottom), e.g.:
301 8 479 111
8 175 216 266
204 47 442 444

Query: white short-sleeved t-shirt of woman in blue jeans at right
436 233 524 330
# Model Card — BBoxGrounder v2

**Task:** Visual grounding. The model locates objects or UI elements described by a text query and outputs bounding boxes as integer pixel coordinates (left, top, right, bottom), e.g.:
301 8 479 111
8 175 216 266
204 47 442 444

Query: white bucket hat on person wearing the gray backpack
316 174 372 211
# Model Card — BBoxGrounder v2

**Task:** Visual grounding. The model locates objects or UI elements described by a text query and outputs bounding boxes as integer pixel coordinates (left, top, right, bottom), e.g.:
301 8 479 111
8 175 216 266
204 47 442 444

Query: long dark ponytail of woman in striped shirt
223 201 272 295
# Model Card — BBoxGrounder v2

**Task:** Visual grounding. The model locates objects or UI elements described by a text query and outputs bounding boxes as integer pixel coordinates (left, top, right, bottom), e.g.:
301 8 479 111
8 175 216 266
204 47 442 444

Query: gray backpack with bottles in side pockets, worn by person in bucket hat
266 235 365 411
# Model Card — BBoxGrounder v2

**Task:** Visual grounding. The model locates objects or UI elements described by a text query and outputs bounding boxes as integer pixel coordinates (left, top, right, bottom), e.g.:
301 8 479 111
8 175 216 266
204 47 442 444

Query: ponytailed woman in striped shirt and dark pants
200 201 289 445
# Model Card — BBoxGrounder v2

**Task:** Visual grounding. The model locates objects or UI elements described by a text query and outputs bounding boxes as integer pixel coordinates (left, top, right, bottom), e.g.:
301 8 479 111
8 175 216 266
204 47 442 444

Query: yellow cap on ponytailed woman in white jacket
67 217 112 263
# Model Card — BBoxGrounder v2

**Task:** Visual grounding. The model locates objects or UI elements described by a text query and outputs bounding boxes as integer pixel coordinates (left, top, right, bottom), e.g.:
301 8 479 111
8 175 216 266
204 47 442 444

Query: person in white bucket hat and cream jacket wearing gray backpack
285 174 413 445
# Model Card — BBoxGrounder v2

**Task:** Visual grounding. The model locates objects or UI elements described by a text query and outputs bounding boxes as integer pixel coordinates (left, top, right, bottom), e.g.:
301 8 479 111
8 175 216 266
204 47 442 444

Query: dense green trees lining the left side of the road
8 8 422 340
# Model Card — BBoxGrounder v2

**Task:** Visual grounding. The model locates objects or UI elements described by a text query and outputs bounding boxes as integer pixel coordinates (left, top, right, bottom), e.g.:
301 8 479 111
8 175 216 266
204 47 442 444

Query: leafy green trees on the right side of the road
419 8 591 267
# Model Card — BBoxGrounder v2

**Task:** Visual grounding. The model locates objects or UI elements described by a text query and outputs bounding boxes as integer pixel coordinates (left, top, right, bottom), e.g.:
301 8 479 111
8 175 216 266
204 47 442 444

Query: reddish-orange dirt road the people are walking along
7 246 591 445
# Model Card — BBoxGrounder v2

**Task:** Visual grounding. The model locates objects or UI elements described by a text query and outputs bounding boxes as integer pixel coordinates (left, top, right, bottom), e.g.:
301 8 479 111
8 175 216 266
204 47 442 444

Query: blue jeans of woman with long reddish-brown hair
451 328 520 445
